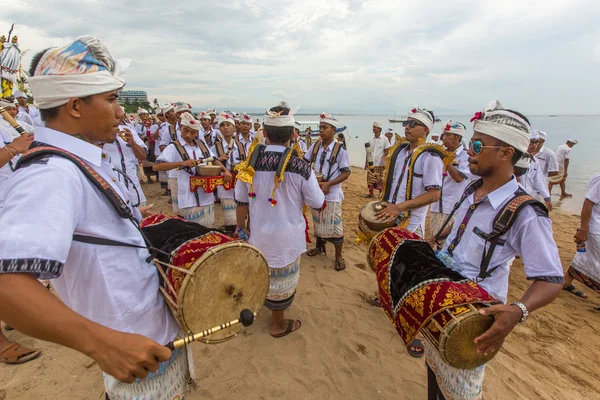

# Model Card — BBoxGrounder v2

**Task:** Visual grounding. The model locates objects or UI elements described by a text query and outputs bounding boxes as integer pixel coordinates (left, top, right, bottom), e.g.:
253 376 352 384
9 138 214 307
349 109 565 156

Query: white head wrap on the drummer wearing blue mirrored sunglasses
471 100 531 153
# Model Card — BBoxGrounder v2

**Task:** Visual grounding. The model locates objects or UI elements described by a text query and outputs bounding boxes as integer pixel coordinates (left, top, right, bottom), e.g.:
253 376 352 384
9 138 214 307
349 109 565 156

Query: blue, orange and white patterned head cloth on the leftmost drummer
27 36 131 110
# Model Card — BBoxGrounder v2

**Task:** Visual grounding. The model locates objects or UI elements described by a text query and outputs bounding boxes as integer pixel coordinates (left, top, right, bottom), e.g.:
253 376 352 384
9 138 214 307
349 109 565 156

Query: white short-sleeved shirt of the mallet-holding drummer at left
0 127 179 343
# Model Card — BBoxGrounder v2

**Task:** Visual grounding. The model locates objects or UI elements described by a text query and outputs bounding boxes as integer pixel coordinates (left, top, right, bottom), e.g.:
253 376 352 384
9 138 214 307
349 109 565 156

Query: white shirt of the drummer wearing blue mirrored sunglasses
444 177 563 303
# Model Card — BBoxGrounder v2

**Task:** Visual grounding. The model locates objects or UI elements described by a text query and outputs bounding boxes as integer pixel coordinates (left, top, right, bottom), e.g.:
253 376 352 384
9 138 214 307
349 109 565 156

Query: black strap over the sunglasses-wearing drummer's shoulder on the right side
477 187 548 282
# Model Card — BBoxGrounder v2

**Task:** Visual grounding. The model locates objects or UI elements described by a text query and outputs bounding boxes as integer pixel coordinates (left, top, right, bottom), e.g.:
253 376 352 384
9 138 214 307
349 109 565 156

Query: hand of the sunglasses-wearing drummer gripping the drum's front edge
475 304 523 354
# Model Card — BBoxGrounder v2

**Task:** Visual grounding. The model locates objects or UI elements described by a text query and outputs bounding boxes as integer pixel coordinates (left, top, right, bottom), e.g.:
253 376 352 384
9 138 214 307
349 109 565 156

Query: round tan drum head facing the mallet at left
177 242 269 343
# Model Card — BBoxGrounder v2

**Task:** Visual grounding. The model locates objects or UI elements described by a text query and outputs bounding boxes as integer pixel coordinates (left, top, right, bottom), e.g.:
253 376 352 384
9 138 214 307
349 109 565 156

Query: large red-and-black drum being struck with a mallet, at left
142 219 269 343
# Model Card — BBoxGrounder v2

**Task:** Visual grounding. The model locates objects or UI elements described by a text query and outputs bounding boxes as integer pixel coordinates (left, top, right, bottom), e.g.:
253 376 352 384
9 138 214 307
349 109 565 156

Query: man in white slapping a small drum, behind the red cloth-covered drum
377 107 444 236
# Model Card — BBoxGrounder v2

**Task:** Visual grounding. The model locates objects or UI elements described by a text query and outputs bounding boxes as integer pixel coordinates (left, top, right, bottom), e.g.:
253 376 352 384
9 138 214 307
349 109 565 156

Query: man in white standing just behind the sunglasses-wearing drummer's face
429 120 471 241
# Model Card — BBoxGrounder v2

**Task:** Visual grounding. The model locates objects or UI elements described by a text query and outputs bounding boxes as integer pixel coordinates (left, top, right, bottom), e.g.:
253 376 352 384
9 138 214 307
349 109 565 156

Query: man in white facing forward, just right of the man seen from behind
304 114 352 271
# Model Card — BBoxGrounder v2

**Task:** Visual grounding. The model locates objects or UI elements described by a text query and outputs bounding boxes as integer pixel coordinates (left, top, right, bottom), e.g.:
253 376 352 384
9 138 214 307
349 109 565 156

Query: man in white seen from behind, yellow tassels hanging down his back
235 103 325 338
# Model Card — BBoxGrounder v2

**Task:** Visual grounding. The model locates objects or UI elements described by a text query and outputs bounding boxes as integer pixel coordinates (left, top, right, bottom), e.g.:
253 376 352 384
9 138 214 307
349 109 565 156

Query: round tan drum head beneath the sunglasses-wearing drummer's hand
440 313 500 369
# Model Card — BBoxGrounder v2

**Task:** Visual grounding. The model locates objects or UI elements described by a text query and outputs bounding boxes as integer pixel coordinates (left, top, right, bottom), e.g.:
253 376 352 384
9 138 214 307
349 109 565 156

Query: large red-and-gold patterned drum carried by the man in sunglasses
367 228 499 369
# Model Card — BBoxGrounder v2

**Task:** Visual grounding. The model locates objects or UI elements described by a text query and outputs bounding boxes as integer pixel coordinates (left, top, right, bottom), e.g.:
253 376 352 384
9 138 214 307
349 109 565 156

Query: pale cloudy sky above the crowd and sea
0 0 600 114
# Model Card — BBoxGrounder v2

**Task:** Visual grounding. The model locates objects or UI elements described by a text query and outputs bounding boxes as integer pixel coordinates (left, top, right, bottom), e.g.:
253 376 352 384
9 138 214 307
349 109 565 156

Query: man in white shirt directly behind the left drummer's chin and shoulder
102 125 148 207
